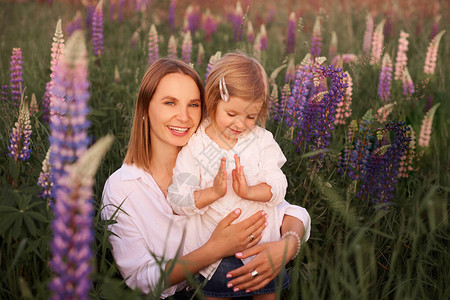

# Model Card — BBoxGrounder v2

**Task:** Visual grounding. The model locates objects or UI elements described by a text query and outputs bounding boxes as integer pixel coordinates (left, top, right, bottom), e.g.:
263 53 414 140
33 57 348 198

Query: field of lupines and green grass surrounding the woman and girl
0 0 450 299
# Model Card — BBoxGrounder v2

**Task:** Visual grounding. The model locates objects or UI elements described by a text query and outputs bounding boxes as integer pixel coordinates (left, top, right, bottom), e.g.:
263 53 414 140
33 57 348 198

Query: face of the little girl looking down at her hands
214 96 262 145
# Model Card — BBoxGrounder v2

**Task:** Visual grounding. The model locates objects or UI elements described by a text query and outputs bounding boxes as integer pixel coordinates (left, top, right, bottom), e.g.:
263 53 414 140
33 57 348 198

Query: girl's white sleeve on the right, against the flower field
257 128 287 205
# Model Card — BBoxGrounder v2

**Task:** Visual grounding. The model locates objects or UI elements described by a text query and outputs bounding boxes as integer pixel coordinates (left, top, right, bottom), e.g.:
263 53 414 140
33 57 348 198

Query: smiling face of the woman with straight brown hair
148 73 202 147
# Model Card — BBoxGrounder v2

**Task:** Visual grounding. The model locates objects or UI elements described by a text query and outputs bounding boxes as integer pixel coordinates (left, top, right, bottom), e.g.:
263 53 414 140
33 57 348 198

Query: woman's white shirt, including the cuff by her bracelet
101 164 311 298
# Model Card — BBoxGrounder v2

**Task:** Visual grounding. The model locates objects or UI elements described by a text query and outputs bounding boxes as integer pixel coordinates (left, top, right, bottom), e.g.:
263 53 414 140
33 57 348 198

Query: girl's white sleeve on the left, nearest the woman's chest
167 140 208 216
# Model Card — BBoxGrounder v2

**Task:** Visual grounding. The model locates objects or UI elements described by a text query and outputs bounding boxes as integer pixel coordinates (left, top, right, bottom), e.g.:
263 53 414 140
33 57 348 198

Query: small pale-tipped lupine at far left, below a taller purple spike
8 99 32 162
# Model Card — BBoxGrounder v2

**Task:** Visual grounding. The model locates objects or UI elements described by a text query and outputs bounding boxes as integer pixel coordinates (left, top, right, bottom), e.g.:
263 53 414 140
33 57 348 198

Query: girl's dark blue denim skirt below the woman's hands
198 256 289 297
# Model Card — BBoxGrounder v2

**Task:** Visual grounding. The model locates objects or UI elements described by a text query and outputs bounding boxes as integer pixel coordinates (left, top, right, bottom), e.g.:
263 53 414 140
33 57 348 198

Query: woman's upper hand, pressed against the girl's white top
208 209 267 258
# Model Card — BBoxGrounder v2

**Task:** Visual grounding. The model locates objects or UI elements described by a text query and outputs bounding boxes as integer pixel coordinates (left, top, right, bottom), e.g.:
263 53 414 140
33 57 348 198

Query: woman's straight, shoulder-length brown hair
123 58 205 170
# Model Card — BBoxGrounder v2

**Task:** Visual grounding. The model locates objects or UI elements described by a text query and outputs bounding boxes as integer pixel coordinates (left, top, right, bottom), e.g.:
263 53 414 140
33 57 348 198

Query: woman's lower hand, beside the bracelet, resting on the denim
227 239 296 292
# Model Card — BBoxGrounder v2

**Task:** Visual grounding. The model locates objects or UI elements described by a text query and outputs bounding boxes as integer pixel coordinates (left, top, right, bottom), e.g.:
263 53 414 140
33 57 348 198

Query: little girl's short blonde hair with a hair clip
205 52 269 125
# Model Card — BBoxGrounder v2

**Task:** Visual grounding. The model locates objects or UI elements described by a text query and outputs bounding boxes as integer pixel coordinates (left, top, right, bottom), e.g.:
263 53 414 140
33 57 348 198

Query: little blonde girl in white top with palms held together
168 53 300 299
